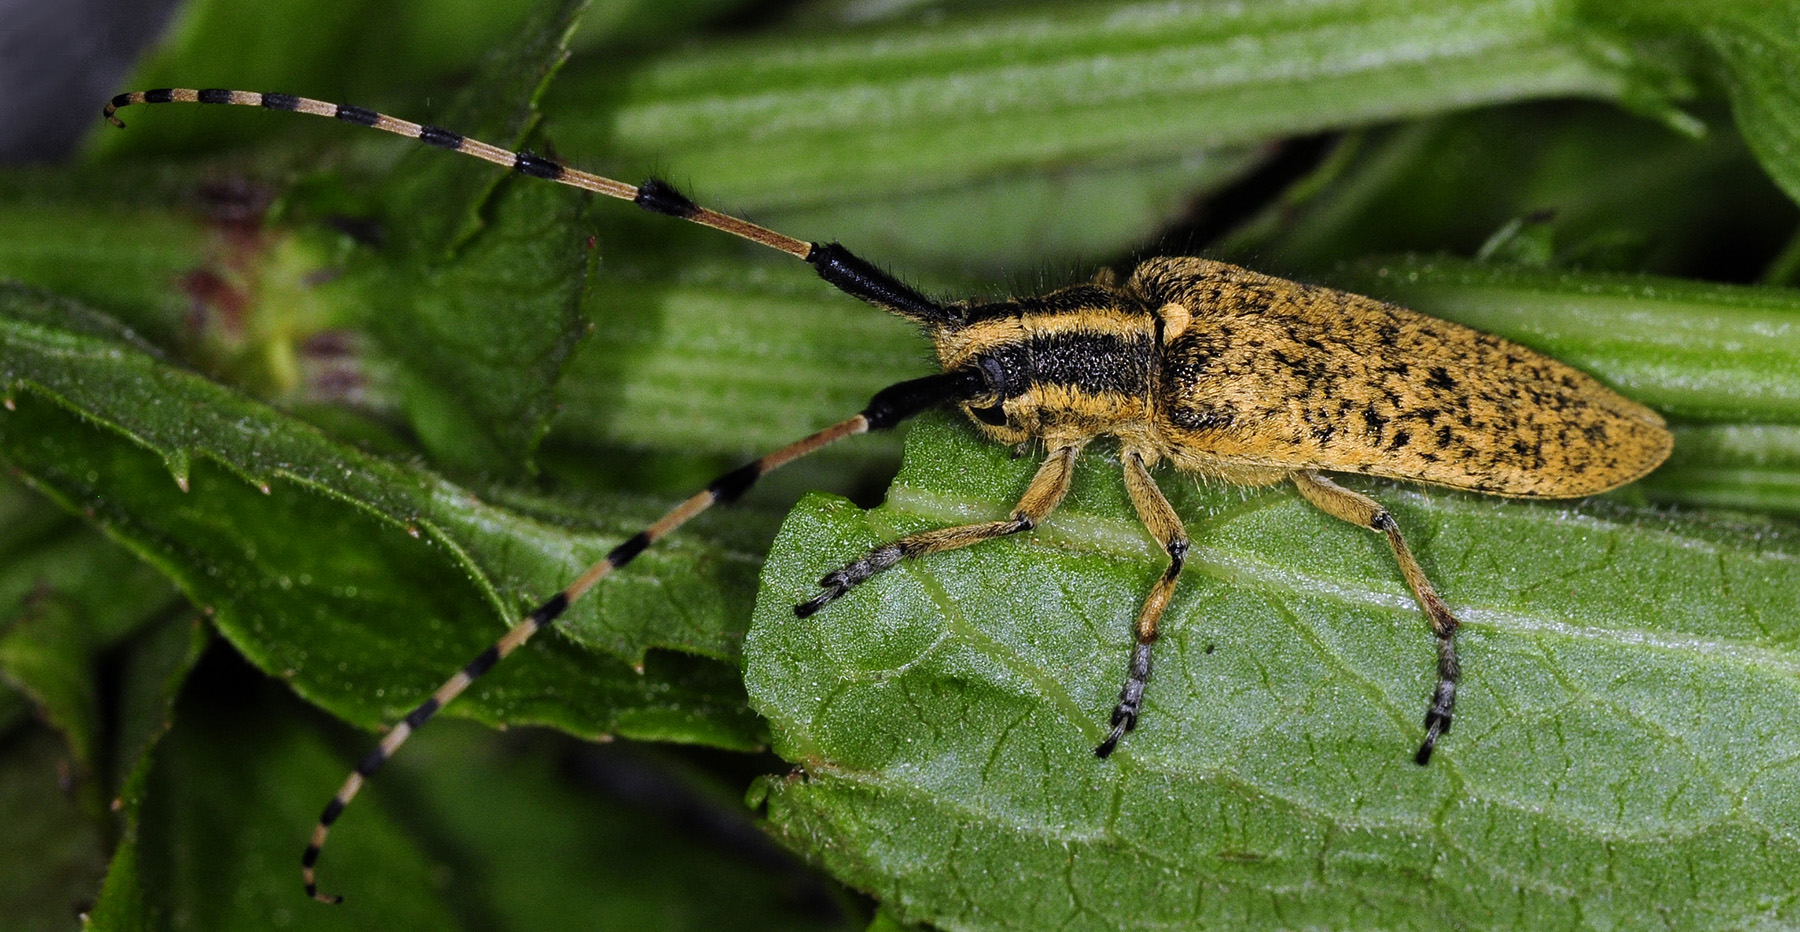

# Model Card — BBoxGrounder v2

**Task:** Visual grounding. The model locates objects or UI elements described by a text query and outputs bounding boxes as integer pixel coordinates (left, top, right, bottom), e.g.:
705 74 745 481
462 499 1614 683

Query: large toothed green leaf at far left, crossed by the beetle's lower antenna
0 288 758 747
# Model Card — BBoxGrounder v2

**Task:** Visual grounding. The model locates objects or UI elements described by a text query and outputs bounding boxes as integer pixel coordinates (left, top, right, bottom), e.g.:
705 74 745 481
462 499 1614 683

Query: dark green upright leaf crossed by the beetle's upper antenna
351 0 592 475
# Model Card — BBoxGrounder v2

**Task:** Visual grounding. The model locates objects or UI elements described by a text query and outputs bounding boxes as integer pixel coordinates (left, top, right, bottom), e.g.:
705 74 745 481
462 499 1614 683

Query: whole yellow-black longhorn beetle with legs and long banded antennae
104 88 1672 903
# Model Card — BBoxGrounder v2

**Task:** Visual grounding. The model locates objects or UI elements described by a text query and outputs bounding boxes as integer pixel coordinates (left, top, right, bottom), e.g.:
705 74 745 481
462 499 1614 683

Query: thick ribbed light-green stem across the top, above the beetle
583 0 1647 207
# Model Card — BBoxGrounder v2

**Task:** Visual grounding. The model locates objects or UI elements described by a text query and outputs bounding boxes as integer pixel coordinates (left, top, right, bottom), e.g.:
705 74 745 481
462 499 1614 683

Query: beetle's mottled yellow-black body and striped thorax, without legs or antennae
932 257 1672 498
